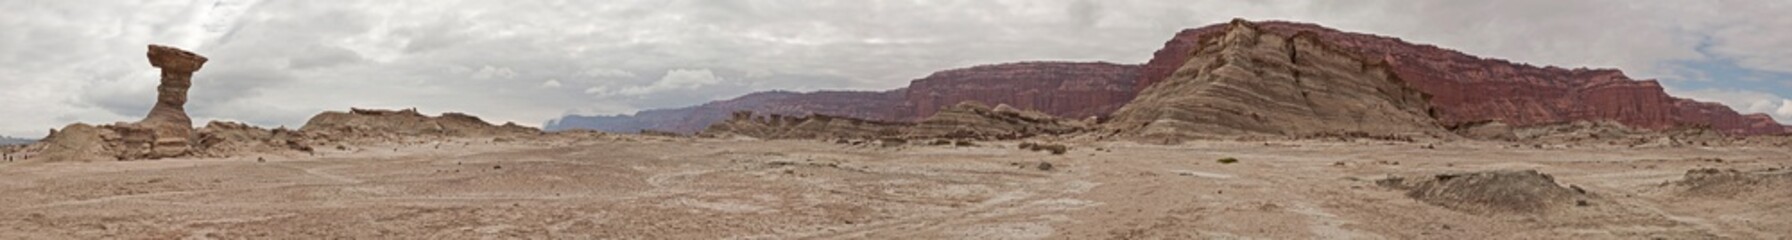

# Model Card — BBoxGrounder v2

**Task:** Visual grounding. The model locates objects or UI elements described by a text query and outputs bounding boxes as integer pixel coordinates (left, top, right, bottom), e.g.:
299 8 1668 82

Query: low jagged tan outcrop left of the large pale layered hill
702 102 1091 140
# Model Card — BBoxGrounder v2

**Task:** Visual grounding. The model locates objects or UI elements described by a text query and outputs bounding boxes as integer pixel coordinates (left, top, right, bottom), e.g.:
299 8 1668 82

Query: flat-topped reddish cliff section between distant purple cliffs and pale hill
907 63 1138 120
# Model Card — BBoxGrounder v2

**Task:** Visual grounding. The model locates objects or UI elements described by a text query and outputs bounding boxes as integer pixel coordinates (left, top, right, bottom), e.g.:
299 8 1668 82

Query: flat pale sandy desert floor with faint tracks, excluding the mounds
0 138 1792 240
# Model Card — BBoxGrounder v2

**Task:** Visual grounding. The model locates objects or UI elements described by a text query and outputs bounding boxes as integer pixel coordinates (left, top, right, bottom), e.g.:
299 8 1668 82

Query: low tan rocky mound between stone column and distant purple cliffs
299 109 541 138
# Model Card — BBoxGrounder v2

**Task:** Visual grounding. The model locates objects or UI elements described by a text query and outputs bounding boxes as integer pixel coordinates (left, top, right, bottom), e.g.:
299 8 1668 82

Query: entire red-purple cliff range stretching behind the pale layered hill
547 21 1792 134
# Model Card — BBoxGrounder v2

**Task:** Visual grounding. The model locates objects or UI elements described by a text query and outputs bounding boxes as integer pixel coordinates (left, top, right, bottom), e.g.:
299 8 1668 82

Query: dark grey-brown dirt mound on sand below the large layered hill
1376 170 1591 213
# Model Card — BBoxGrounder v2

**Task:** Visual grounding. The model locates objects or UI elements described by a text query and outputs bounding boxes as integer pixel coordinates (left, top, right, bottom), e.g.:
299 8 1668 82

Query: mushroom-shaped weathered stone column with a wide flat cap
136 45 206 158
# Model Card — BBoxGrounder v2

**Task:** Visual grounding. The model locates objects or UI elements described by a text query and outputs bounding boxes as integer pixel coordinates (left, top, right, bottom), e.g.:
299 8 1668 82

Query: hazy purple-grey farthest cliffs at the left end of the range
543 90 907 134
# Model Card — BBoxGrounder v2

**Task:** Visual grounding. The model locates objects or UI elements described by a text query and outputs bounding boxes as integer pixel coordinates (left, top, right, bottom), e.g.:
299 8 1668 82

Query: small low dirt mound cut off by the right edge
1665 168 1792 201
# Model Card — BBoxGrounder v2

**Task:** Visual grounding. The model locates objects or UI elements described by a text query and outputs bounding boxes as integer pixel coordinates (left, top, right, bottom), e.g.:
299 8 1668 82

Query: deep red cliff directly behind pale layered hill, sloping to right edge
1138 21 1787 134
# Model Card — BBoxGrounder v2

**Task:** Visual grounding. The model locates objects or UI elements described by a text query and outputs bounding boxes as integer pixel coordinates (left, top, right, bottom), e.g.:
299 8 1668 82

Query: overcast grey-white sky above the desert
0 0 1792 138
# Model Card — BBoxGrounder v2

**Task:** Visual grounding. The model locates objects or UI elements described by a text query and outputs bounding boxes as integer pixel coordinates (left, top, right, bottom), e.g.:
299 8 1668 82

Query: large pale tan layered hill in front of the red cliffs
1109 20 1444 141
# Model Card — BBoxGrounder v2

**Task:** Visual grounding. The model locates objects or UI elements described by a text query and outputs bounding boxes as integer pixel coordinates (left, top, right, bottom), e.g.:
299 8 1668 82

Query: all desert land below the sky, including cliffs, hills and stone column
0 20 1792 240
